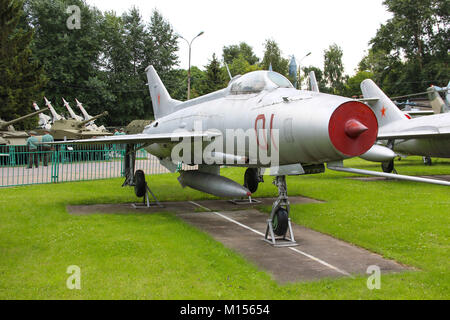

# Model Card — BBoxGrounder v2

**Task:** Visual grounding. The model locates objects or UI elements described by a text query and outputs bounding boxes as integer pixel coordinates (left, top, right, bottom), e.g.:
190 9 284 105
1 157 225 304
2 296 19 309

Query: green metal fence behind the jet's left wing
0 144 188 187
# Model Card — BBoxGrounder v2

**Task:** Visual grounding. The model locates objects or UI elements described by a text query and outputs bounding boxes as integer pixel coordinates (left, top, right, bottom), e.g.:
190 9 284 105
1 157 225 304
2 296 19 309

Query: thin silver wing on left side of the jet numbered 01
49 130 221 144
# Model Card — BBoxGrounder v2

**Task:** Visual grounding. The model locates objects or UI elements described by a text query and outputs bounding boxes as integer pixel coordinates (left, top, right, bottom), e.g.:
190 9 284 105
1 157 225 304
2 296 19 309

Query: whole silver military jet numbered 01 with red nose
51 66 450 245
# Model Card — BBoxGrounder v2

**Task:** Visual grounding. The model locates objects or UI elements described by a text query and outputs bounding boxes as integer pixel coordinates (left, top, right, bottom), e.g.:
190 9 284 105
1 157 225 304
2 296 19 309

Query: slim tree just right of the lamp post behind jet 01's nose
323 44 345 94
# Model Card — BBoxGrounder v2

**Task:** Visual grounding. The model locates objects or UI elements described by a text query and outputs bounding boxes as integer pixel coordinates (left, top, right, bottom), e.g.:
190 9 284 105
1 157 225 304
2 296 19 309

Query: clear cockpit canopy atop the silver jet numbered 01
230 71 294 94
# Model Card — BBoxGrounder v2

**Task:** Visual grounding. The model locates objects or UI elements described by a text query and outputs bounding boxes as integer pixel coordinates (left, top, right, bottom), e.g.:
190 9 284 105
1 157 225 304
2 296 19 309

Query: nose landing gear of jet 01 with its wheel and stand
264 176 298 247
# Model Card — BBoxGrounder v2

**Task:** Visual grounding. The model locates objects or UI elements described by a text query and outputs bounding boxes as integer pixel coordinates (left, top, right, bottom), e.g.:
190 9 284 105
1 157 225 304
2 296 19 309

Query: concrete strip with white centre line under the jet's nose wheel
178 209 407 283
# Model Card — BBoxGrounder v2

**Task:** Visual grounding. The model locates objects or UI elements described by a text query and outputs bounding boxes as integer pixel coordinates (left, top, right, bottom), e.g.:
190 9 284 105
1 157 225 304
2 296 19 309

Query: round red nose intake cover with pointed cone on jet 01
328 101 378 157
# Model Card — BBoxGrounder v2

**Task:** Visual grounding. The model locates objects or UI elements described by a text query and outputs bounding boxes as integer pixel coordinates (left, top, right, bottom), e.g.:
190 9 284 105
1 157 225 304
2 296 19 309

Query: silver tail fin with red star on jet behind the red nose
361 79 406 127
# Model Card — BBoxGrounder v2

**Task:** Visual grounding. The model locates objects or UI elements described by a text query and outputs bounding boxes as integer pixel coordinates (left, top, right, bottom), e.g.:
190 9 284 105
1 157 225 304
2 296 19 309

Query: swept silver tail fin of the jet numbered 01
145 66 181 119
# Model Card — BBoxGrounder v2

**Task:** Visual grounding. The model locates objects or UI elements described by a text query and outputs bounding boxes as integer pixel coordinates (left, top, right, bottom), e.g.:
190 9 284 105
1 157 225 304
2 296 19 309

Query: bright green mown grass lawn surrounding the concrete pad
0 157 450 299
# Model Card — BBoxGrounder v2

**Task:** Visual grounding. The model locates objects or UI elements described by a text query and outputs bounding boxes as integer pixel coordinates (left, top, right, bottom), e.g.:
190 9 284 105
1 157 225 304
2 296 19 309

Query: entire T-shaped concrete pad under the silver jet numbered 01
67 197 408 283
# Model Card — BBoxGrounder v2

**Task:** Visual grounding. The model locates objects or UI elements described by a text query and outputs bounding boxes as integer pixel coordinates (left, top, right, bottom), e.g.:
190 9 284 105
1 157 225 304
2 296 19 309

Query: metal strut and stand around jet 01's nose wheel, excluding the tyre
263 176 298 247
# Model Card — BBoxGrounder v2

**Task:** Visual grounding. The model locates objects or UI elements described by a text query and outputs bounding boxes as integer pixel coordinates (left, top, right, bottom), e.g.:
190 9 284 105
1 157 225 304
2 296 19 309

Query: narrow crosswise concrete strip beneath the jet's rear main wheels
67 197 320 215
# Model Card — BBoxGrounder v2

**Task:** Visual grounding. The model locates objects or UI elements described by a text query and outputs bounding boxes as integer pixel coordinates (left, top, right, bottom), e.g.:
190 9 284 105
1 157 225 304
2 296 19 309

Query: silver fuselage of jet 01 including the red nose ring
143 76 378 166
